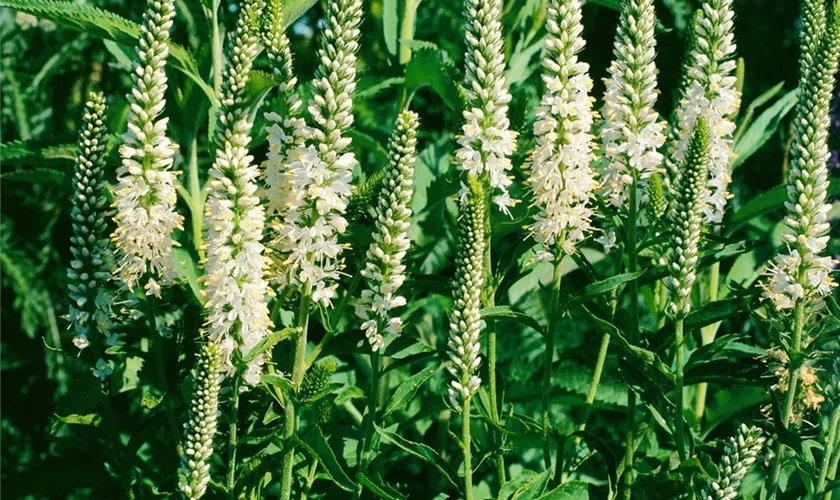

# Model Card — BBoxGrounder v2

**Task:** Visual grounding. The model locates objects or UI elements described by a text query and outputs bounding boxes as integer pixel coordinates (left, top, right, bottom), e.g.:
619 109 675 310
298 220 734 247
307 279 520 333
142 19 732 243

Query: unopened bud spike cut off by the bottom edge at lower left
178 342 222 500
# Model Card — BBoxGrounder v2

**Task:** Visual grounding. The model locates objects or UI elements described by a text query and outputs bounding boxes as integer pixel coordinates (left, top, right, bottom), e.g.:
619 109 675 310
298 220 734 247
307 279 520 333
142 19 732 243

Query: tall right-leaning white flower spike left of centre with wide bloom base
267 0 362 307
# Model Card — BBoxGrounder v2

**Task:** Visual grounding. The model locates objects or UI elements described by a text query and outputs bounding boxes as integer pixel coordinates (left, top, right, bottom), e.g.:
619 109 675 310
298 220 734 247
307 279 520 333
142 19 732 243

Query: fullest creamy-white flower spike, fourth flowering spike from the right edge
527 0 598 254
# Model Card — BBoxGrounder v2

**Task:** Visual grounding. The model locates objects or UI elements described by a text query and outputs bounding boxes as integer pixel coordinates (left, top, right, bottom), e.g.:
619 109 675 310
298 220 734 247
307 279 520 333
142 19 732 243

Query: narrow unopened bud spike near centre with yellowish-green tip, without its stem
447 177 487 411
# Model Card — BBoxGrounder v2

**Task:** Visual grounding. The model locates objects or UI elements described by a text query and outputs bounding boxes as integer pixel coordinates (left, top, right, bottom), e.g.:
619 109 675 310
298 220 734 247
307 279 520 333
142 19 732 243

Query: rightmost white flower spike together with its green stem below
762 0 840 494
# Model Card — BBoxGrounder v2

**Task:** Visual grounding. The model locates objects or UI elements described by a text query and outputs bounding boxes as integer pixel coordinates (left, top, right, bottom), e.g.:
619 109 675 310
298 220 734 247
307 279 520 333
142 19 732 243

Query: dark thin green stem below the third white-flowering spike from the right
622 178 639 500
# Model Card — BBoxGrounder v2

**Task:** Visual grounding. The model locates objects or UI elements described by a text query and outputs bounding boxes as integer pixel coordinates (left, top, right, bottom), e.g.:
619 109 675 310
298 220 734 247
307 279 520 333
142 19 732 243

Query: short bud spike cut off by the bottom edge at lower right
700 424 766 500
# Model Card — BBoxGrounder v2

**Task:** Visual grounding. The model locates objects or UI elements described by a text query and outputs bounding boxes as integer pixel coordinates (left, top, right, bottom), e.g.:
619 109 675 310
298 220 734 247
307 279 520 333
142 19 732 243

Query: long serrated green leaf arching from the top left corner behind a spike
0 0 217 104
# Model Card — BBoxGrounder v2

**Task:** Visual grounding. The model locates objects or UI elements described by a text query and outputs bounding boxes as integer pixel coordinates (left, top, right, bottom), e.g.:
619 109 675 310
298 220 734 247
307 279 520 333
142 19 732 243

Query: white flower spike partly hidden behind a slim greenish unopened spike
671 0 741 224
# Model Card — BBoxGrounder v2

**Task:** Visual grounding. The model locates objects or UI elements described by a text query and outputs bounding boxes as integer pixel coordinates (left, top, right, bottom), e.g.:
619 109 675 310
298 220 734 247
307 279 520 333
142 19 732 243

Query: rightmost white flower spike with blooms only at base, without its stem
762 3 840 310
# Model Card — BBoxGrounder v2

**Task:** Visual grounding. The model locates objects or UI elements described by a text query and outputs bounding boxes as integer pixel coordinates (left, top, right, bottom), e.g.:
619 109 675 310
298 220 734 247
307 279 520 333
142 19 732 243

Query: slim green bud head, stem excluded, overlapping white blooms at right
668 118 710 318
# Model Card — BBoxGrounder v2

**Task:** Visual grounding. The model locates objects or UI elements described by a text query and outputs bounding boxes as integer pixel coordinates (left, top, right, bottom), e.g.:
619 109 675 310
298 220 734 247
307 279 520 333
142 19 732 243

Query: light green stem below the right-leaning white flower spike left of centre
280 290 311 500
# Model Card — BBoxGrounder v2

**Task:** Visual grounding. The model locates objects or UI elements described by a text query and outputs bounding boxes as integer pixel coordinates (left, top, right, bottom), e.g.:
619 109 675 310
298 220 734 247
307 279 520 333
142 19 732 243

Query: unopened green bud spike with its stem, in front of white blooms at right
668 118 711 460
